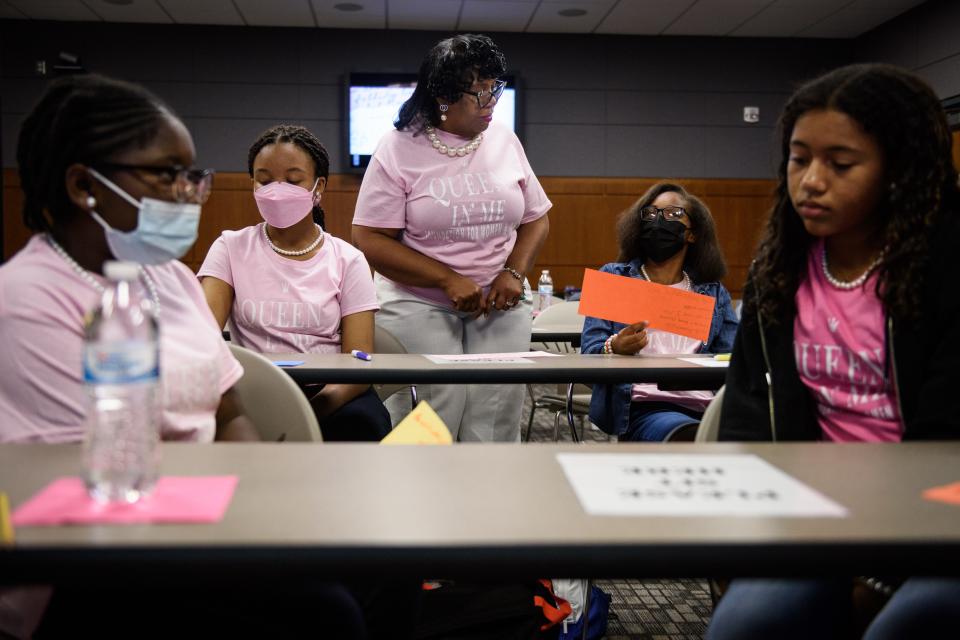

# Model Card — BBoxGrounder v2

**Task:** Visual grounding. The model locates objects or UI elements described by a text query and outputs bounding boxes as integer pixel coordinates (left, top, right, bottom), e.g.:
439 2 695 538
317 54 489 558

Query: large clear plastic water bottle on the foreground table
83 262 161 502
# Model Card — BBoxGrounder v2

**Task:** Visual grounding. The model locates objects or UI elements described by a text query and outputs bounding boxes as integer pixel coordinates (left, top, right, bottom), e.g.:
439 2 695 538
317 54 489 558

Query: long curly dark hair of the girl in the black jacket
744 64 960 324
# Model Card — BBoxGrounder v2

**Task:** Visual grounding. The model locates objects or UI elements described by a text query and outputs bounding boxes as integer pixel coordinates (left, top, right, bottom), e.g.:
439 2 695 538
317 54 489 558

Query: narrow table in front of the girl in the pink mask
264 353 727 389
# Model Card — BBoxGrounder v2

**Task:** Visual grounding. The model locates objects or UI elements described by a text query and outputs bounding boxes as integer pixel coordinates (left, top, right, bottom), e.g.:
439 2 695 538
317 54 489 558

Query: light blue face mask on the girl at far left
89 169 200 264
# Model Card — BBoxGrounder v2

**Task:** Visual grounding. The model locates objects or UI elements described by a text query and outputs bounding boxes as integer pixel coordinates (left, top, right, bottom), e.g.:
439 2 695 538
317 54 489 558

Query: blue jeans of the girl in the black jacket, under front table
706 578 960 640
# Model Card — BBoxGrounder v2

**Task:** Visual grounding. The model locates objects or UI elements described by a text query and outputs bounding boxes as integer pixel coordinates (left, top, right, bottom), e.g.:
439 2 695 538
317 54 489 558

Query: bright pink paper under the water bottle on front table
13 476 237 527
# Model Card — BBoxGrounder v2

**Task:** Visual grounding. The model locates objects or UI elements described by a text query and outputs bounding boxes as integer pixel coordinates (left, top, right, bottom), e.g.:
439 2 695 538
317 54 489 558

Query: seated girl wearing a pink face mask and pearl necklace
198 125 390 440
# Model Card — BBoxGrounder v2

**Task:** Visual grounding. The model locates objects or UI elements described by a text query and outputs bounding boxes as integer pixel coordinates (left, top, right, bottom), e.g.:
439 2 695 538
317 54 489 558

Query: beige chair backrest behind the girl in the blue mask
229 344 323 442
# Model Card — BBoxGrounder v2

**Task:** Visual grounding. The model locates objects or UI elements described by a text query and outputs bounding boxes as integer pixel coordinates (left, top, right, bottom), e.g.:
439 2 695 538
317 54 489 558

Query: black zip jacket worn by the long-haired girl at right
719 220 960 441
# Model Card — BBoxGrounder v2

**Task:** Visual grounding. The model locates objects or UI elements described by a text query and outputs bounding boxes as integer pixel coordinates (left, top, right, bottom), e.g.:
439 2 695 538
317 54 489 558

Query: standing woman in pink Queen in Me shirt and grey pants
353 34 551 441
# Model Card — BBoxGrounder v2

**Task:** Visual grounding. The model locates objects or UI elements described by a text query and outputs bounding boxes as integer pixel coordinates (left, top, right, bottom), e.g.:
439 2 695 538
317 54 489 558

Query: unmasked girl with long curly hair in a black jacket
707 64 960 640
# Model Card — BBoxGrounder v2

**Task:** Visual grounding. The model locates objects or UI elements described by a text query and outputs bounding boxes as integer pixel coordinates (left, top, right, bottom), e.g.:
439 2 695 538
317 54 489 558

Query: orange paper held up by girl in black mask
580 269 716 342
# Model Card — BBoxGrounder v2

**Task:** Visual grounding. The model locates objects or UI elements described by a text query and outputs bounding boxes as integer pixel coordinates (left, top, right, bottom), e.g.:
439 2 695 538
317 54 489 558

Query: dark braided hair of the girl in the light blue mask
17 74 173 232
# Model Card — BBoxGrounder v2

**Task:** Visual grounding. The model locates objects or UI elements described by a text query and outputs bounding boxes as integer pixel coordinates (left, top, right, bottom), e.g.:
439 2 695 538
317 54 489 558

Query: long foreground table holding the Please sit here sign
0 442 960 585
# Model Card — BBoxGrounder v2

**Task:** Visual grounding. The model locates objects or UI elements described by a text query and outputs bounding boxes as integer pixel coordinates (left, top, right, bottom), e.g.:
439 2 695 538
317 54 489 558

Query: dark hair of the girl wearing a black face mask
617 182 727 282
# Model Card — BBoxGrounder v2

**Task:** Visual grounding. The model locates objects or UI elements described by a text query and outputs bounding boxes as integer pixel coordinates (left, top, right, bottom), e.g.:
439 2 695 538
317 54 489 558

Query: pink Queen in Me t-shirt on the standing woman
353 123 551 305
